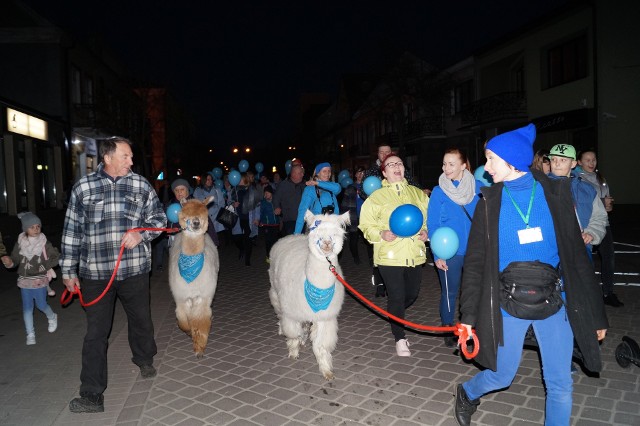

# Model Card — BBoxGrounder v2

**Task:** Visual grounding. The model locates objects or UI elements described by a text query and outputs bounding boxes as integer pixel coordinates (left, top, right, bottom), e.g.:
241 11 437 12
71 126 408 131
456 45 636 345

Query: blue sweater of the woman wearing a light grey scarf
427 180 484 261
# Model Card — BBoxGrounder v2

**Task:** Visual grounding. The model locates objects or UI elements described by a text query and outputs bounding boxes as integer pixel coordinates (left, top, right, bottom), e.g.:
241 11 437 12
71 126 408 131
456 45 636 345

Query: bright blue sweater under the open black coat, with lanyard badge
498 173 560 271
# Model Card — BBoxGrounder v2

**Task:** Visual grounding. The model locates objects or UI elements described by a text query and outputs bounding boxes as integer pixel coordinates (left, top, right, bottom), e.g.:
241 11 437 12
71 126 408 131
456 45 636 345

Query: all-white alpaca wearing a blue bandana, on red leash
269 210 349 380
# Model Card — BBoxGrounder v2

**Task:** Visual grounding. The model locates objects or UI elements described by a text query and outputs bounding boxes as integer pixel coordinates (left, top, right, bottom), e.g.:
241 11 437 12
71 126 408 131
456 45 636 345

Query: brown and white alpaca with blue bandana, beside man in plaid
169 197 220 358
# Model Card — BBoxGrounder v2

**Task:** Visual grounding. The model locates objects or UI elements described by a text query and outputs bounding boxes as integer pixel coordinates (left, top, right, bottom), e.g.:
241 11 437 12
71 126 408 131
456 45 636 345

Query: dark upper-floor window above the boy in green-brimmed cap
542 34 588 89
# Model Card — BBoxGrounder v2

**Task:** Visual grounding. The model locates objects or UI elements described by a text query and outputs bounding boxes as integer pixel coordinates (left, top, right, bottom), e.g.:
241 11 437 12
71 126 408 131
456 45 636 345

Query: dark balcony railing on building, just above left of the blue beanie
460 92 527 126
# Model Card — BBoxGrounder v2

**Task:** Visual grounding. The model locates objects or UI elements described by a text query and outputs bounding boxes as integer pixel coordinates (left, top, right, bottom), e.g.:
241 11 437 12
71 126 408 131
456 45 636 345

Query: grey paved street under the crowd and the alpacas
0 213 640 426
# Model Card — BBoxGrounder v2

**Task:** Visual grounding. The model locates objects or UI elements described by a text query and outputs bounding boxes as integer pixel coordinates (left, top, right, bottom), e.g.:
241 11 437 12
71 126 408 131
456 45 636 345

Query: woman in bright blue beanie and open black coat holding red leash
454 124 609 425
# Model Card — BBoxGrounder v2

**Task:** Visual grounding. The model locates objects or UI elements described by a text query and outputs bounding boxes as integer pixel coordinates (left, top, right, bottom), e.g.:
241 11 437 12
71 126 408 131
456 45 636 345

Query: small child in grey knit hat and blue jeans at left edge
2 212 60 345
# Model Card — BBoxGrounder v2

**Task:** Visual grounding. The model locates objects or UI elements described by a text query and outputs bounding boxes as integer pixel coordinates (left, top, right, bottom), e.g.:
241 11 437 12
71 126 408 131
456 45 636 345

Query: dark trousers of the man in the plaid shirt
80 273 157 396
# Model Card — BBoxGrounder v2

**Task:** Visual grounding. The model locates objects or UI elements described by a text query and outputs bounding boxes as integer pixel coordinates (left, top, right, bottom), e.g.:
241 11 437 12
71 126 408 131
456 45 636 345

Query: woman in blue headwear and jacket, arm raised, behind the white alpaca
293 163 342 234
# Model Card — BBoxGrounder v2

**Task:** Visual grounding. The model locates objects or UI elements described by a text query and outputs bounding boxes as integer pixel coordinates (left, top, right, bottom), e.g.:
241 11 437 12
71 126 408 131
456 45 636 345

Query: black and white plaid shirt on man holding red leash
60 164 167 280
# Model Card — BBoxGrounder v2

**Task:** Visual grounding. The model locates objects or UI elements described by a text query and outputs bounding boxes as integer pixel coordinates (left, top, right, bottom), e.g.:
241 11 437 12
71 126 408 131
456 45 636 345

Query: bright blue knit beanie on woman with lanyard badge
486 124 536 172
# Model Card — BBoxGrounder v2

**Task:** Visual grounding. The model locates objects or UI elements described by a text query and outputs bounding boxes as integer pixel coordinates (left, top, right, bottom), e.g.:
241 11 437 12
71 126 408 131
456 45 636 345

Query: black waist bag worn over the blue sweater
499 260 564 320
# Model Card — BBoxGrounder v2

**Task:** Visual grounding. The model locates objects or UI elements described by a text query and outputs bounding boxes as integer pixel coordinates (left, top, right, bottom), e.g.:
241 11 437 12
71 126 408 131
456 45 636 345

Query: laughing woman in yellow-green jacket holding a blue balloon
358 153 429 356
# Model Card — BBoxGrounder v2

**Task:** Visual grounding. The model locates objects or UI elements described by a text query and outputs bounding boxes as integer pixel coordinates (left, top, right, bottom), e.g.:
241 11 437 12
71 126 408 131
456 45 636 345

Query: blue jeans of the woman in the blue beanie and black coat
462 306 573 426
